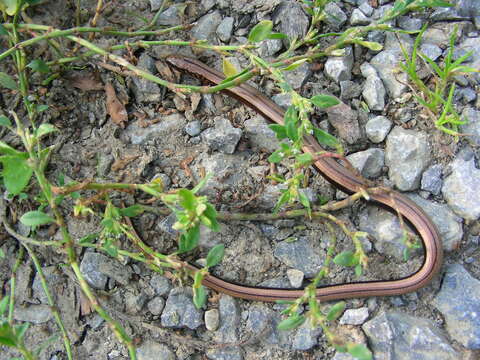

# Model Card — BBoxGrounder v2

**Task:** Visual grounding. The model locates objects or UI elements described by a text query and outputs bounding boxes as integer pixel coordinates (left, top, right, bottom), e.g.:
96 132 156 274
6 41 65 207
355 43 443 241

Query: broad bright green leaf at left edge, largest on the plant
0 155 33 195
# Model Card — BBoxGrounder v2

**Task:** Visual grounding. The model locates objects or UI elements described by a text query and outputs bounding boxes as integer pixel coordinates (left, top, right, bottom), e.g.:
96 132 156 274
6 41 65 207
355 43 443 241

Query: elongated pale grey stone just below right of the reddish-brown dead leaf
124 113 187 145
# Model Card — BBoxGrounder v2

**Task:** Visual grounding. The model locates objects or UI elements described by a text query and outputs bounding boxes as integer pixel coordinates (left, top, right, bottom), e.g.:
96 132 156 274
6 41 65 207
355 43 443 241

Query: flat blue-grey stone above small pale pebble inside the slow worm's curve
273 237 324 277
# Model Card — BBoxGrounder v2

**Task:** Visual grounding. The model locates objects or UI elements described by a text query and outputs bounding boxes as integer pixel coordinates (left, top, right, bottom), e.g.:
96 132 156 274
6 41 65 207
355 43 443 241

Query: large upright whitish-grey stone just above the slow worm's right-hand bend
385 126 431 191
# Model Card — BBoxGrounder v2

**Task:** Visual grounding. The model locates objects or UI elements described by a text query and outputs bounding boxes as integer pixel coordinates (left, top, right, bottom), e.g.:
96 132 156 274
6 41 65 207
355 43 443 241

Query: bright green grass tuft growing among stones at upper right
400 24 479 136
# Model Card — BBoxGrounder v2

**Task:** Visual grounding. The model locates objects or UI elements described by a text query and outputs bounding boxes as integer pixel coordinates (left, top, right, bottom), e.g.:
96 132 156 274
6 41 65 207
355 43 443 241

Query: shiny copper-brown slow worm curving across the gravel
167 55 443 301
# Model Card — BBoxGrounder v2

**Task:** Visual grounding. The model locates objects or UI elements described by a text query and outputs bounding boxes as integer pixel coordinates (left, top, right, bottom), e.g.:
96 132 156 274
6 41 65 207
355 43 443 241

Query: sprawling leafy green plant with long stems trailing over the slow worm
0 0 453 360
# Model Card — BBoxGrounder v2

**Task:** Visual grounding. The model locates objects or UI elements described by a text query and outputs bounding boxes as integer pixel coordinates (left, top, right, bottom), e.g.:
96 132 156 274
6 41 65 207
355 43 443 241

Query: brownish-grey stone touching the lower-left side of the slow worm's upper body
243 115 280 152
